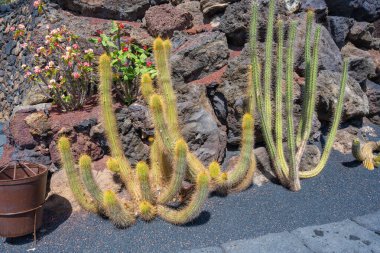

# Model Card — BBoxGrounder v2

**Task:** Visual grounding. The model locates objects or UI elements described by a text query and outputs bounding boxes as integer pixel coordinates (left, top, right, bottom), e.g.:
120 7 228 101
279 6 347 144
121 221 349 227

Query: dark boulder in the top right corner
325 0 380 22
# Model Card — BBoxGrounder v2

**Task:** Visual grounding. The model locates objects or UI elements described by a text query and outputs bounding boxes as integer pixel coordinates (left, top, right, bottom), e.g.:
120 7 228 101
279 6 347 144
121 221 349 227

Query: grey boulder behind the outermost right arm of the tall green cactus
317 70 369 121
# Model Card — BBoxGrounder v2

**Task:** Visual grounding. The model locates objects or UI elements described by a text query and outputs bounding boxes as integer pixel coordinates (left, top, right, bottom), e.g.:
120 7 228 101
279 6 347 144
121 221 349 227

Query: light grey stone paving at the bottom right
181 211 380 253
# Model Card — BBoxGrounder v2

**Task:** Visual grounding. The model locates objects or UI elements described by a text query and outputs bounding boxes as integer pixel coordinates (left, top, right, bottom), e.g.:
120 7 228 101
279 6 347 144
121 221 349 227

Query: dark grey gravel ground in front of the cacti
0 125 380 252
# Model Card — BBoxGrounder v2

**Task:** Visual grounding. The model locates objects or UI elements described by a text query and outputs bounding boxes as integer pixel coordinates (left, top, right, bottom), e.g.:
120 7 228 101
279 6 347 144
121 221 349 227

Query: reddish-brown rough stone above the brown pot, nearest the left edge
8 112 37 149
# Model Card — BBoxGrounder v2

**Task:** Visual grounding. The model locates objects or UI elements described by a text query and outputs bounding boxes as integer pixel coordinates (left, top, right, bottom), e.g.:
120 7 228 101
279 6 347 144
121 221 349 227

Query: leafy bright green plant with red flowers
90 22 157 104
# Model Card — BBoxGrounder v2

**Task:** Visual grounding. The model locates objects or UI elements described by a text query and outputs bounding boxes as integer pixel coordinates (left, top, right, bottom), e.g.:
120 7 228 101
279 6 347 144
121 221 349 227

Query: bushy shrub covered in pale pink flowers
14 25 95 111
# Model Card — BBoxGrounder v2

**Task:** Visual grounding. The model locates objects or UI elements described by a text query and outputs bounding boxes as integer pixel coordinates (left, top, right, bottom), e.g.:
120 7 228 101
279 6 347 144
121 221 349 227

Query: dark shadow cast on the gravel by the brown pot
5 194 73 245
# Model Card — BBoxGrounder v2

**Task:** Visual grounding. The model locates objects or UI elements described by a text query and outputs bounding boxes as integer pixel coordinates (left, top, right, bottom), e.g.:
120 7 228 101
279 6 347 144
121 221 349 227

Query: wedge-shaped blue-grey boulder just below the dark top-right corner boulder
327 16 354 49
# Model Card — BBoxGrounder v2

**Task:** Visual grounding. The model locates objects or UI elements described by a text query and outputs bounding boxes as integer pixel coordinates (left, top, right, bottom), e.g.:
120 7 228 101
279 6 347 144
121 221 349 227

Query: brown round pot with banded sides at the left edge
0 162 48 237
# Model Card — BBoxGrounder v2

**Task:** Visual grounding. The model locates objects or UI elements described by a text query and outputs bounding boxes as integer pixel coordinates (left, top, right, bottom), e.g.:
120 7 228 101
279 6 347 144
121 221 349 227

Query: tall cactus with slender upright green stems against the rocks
250 0 348 191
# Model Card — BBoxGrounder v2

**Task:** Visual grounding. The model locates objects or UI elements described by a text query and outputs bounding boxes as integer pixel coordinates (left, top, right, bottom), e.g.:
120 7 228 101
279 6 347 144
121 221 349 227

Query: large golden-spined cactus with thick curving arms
58 38 256 227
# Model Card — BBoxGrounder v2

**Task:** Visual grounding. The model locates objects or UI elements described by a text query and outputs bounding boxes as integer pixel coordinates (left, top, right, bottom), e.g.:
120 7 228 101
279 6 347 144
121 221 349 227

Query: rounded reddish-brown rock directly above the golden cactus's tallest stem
145 4 193 38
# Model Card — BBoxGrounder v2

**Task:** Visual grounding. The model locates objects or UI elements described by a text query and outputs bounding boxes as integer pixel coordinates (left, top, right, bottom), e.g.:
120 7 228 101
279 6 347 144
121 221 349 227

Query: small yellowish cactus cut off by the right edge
352 138 380 170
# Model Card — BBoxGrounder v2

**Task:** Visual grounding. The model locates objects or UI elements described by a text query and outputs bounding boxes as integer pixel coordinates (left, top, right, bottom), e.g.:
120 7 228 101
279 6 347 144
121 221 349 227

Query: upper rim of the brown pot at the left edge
0 161 48 186
